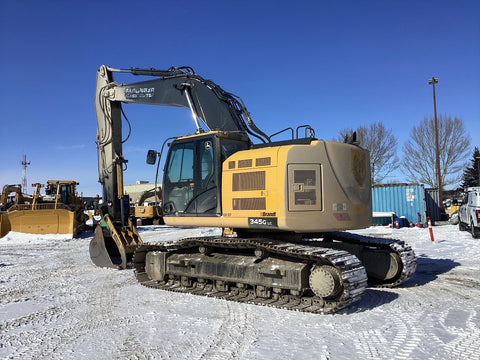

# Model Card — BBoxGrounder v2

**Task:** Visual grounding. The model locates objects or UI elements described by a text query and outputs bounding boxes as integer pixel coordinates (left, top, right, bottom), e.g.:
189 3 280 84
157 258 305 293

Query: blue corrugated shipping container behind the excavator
372 184 427 224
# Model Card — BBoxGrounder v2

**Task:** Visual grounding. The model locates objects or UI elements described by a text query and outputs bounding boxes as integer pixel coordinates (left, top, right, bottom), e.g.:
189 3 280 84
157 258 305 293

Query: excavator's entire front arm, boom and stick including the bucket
90 65 270 268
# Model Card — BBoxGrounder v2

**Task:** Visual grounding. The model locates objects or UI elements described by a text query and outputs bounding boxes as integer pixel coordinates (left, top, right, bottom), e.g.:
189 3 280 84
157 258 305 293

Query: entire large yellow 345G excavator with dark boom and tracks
90 66 416 313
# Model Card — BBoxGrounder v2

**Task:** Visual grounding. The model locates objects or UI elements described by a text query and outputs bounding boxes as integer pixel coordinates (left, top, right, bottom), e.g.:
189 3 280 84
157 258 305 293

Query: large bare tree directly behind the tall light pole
403 115 470 187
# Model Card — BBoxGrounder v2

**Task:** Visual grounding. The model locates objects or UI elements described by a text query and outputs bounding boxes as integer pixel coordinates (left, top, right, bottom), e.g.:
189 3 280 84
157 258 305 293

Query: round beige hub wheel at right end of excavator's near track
309 265 343 298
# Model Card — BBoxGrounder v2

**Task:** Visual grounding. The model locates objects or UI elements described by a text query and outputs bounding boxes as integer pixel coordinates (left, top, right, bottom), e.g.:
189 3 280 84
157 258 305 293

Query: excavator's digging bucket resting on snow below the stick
90 215 143 269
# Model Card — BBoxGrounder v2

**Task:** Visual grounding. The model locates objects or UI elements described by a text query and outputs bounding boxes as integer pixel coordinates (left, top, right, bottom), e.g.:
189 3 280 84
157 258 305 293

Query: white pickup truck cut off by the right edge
458 187 480 238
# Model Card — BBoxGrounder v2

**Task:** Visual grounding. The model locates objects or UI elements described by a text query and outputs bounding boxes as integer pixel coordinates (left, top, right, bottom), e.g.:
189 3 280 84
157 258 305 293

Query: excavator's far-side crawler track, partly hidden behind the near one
312 231 417 288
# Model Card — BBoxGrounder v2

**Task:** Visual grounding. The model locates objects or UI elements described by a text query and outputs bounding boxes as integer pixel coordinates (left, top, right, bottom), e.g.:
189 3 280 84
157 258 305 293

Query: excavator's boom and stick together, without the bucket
95 65 270 228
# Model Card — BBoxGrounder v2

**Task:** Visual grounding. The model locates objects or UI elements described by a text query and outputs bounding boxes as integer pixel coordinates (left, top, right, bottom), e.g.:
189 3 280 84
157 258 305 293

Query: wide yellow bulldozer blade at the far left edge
0 209 82 237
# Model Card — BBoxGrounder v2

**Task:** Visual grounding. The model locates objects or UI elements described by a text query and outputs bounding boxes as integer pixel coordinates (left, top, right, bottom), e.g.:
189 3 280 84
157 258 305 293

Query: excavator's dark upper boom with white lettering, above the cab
96 66 269 142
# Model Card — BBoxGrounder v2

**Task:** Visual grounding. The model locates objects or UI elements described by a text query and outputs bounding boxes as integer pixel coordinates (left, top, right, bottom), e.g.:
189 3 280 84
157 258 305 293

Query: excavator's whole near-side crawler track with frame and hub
133 237 367 314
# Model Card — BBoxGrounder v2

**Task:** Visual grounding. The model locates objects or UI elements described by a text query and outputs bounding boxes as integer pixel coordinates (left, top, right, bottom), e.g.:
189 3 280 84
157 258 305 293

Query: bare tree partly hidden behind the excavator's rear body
340 122 399 185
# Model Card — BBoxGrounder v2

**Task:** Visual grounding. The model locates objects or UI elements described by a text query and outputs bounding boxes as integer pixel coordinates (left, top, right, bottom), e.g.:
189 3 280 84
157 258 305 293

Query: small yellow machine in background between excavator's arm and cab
133 186 164 226
